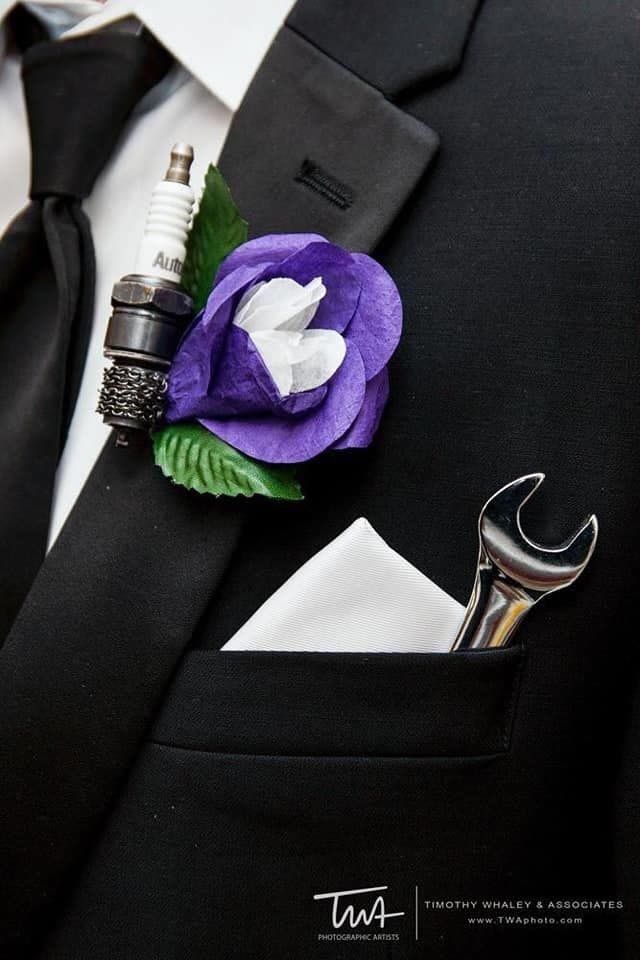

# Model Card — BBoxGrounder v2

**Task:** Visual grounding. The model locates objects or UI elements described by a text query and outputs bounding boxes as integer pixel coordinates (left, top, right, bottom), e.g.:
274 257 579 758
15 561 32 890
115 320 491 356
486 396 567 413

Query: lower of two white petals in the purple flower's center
249 330 347 397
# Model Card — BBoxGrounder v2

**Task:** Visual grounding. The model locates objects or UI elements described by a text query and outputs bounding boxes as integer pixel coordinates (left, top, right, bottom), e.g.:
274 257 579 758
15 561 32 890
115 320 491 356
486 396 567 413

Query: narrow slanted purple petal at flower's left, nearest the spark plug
165 266 262 423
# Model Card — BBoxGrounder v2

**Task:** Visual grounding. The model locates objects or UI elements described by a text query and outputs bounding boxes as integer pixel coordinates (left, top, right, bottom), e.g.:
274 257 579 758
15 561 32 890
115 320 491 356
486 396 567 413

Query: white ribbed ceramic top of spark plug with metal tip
135 143 195 283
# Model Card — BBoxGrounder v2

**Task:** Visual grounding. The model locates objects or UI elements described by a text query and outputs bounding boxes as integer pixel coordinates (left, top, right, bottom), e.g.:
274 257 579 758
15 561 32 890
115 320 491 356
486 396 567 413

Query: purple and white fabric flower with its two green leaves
153 166 402 500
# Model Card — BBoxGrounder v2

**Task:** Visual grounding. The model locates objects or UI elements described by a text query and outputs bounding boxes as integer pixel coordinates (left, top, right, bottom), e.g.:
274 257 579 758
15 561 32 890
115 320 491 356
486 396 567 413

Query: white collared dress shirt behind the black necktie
0 0 293 545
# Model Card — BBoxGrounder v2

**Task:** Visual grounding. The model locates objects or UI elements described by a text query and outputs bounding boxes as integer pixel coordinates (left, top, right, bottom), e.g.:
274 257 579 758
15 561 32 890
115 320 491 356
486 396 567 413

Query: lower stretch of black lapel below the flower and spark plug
0 441 245 957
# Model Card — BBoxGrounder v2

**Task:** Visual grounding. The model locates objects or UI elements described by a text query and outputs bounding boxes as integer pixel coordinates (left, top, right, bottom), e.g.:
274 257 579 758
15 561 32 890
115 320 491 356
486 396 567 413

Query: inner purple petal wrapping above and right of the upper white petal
265 242 360 333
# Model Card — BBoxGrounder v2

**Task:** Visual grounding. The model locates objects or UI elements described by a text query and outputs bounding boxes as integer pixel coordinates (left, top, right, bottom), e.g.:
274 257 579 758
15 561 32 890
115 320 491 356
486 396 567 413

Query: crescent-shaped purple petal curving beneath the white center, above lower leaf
200 346 366 463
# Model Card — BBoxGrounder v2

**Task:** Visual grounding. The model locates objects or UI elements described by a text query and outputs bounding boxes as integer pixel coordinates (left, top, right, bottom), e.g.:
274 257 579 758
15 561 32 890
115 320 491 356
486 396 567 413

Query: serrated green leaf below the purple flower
153 423 304 500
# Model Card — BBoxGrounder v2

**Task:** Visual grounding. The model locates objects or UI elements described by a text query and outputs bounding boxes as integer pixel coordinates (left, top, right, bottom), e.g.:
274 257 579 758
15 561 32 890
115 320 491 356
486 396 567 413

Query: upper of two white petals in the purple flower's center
233 277 327 333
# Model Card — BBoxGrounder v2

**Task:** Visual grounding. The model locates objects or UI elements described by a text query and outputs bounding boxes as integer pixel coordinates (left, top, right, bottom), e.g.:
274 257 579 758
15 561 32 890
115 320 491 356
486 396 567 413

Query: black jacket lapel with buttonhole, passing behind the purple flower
0 20 437 956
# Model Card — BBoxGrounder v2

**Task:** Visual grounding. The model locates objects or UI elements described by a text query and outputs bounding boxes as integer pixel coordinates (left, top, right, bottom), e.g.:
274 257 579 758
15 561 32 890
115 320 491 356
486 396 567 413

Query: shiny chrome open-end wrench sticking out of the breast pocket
451 473 598 650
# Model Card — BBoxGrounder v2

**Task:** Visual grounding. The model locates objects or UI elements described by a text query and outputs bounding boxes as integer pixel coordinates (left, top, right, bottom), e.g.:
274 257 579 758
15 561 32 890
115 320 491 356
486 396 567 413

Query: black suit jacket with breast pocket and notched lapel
0 0 640 960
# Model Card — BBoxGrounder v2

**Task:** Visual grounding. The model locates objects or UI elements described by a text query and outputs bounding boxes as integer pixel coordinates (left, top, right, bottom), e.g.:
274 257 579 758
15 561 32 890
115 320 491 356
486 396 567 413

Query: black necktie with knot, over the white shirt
0 32 168 642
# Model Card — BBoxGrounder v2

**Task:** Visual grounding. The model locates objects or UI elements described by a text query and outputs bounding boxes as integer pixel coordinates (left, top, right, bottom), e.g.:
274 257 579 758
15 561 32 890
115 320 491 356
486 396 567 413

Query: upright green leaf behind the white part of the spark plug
182 164 247 311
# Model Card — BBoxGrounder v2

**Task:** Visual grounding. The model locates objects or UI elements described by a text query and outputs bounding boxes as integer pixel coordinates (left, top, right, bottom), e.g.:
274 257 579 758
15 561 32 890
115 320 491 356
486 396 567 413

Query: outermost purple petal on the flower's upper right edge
344 253 402 380
